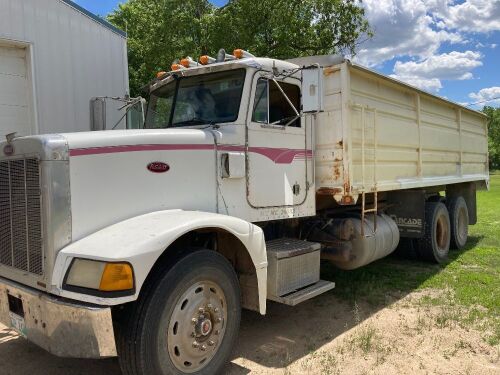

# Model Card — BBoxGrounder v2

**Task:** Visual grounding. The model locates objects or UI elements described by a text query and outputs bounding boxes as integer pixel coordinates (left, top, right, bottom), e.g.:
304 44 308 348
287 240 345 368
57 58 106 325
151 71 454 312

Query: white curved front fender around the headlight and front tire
51 210 267 314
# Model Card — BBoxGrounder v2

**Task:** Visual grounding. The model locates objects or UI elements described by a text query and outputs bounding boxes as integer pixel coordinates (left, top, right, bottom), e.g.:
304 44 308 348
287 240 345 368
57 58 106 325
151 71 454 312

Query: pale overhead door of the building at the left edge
0 45 32 140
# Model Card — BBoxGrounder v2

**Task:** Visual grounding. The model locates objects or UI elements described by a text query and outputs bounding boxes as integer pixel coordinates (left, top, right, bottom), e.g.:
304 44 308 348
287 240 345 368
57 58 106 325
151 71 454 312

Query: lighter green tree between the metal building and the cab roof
108 0 214 95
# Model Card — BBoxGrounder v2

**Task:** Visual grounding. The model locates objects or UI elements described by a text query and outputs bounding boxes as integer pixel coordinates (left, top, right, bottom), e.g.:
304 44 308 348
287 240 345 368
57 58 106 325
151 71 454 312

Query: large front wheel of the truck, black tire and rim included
119 250 241 375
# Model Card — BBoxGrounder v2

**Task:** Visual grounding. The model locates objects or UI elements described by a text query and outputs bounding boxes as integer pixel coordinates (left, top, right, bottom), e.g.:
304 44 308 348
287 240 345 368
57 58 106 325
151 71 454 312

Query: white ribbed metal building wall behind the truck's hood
0 0 128 134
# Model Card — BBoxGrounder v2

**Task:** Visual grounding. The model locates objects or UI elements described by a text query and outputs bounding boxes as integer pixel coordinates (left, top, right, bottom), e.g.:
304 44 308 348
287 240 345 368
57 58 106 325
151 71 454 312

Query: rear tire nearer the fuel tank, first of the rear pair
417 202 451 263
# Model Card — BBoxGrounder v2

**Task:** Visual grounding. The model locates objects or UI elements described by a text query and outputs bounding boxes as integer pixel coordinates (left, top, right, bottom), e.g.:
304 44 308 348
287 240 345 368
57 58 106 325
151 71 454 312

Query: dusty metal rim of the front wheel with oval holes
167 281 227 373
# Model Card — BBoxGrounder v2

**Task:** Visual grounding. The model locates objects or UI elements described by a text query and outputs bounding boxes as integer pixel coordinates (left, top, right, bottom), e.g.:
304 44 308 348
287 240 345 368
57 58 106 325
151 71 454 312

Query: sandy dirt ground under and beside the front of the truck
0 292 500 375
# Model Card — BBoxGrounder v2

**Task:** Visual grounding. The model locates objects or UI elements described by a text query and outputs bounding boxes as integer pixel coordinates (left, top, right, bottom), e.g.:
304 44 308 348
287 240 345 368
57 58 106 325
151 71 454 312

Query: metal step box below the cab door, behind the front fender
266 238 321 299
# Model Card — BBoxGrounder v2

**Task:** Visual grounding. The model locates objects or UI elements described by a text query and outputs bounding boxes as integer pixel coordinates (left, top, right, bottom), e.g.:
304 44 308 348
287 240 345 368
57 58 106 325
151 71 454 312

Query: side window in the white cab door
252 78 300 128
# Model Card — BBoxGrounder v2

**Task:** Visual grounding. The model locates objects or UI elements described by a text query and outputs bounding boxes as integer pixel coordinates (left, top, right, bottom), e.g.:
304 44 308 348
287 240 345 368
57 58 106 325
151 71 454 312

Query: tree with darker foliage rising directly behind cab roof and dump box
211 0 371 59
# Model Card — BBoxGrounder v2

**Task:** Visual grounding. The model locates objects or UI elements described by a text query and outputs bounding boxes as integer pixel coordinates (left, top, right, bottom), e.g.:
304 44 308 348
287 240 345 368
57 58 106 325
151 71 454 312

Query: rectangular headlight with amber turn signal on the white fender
64 259 134 294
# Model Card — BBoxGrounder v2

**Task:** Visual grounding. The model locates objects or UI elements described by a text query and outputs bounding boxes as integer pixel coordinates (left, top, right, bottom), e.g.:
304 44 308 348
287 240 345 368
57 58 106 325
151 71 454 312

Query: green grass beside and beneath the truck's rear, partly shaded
322 175 500 345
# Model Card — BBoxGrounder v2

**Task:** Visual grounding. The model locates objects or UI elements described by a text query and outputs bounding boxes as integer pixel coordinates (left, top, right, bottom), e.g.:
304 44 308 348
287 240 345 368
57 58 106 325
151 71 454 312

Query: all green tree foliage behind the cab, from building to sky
108 0 371 95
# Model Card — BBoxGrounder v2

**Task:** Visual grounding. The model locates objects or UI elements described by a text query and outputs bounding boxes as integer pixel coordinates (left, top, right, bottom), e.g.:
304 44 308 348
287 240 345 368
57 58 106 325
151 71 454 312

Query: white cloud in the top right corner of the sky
426 0 500 33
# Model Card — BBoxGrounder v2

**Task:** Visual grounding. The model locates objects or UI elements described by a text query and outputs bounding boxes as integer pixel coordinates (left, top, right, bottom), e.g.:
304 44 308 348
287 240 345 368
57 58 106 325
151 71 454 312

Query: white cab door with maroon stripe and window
246 75 311 208
